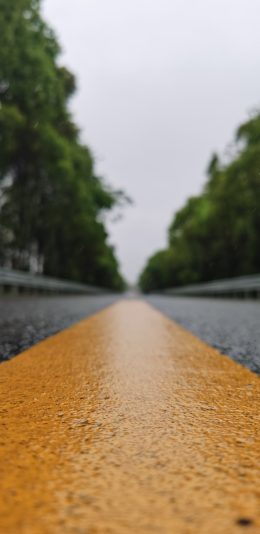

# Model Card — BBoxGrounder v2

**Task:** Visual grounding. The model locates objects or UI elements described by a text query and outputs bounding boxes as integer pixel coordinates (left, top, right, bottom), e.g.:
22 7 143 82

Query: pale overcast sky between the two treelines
43 0 260 283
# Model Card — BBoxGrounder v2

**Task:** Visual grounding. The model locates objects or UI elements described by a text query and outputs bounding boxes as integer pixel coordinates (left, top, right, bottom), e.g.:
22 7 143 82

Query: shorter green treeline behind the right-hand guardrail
139 113 260 292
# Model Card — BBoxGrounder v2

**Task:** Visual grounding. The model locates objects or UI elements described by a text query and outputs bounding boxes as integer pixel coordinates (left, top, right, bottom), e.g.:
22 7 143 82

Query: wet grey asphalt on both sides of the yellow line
0 295 260 374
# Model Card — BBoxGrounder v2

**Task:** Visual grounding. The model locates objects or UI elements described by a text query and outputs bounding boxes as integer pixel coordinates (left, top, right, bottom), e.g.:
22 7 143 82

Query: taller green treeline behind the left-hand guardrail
0 0 127 290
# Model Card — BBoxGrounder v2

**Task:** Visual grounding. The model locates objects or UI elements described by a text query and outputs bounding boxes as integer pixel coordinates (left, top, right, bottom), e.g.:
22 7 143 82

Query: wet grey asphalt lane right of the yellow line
147 296 260 374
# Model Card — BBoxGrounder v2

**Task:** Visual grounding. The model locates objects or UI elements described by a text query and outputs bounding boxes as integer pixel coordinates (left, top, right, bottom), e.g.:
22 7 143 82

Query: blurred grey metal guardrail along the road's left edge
0 267 105 295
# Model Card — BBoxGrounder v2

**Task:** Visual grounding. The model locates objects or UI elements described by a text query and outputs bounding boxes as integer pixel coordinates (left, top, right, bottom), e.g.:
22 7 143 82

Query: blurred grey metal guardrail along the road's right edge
163 274 260 298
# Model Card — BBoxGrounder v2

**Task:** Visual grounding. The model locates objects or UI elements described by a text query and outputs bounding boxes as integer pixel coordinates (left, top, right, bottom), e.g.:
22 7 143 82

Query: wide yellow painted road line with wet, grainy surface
0 301 260 534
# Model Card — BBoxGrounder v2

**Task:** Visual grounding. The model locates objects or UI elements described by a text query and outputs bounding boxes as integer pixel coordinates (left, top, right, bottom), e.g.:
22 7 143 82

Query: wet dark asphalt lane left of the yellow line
0 295 118 362
